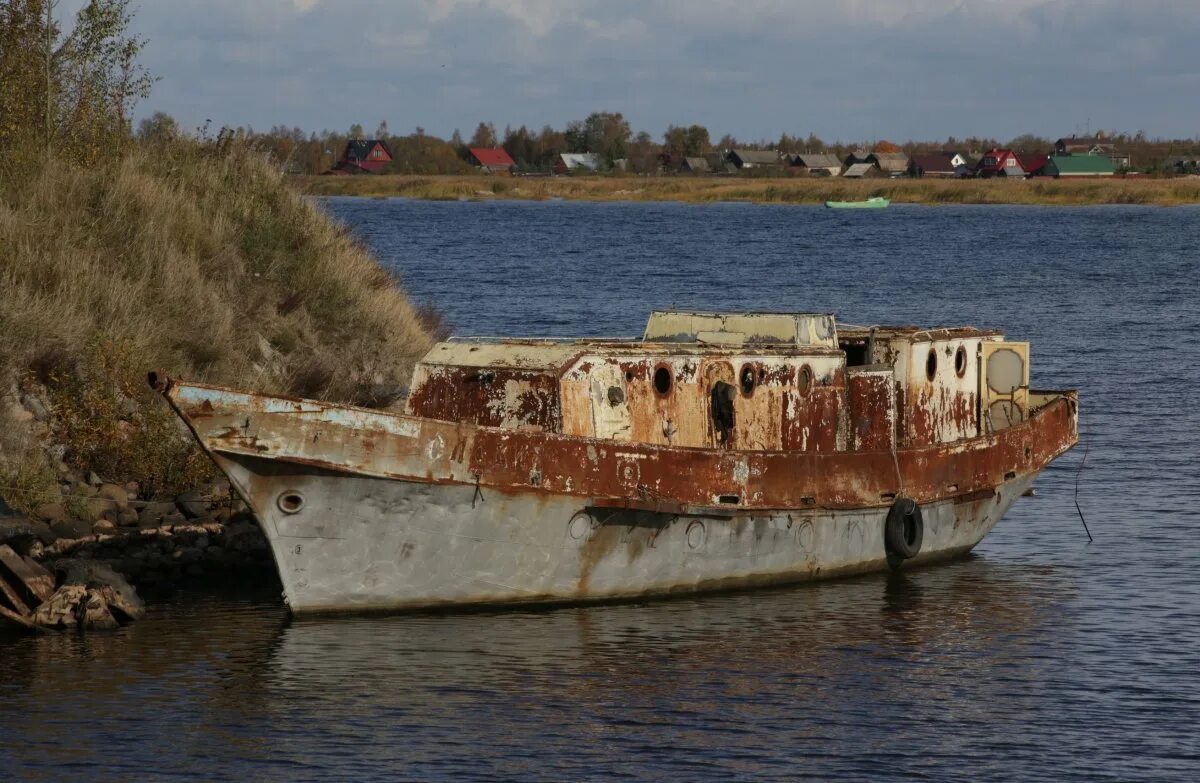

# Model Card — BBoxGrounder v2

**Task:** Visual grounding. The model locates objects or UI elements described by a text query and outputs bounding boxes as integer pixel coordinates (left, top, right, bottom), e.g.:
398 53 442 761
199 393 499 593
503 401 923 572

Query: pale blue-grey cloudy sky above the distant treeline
60 0 1200 142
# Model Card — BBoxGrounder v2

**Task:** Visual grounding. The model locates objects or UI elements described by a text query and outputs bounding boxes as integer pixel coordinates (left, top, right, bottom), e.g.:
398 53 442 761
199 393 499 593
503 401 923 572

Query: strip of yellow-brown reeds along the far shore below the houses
290 174 1200 207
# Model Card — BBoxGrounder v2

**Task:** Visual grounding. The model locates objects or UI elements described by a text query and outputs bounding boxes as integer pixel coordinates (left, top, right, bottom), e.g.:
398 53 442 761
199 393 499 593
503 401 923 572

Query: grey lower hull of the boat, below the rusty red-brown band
215 454 1036 614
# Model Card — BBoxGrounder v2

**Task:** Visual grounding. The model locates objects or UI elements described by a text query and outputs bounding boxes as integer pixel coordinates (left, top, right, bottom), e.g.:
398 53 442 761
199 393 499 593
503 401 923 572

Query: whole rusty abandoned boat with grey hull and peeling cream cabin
150 312 1078 612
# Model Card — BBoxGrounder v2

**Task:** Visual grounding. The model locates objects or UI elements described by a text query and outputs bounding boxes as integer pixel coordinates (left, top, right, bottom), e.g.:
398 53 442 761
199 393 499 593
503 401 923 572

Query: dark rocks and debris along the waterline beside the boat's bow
0 395 274 629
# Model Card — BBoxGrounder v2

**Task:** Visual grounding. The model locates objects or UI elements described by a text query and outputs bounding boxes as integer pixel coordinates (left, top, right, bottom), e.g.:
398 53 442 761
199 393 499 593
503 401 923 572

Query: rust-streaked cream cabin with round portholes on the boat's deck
407 312 1030 452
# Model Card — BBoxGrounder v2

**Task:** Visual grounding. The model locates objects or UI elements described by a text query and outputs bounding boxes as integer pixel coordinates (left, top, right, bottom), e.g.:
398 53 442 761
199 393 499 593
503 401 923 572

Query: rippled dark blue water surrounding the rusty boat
0 199 1200 781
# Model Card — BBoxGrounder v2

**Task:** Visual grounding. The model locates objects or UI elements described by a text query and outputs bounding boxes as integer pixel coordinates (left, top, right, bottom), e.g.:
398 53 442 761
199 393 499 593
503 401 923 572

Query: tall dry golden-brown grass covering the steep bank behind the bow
0 142 431 504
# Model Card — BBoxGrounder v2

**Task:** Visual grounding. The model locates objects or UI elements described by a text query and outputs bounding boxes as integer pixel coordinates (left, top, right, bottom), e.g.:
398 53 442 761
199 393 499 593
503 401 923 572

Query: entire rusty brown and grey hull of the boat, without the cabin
152 383 1078 612
